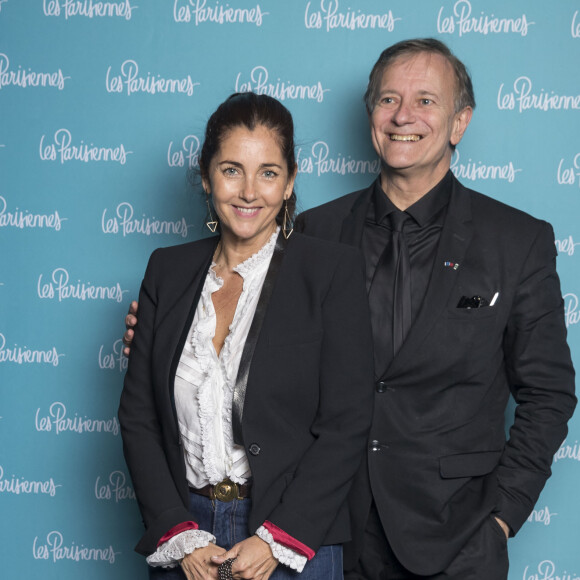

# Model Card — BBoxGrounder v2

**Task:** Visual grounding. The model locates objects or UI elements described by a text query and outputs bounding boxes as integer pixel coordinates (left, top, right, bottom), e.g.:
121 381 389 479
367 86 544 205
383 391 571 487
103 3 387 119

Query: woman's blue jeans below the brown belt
149 493 343 580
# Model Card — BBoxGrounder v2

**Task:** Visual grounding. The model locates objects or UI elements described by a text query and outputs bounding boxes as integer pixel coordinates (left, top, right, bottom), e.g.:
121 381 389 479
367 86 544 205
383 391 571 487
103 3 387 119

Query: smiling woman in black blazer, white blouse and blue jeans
119 93 373 580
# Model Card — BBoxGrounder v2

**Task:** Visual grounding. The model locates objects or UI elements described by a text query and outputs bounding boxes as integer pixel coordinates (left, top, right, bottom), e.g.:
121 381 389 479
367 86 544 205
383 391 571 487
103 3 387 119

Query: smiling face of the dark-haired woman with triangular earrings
203 125 295 247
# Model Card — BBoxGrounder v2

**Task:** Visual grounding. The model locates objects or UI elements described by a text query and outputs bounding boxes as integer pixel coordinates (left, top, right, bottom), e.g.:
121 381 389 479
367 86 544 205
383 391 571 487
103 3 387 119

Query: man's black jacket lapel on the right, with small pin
385 178 473 374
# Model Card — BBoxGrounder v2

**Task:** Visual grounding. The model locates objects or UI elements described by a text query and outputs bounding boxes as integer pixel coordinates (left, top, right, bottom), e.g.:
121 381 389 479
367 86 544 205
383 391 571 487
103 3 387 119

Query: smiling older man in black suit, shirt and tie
123 39 576 580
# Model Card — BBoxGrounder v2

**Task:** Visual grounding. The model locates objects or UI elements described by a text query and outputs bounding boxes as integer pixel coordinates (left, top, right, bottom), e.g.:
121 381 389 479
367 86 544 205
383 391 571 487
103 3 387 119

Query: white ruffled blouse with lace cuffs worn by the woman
147 228 307 572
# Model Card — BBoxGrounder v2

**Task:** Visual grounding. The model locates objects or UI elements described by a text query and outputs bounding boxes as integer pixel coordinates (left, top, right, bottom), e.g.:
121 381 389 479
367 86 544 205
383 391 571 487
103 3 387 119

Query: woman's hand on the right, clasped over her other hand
212 536 278 580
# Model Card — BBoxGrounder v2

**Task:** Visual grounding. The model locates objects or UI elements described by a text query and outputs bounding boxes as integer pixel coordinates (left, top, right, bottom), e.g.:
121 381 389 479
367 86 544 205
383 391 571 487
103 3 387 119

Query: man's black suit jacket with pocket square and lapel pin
297 178 576 575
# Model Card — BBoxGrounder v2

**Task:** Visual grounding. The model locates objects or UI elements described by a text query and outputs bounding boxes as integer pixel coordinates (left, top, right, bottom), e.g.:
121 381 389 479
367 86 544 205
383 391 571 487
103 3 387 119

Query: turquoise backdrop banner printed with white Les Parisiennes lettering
0 0 580 580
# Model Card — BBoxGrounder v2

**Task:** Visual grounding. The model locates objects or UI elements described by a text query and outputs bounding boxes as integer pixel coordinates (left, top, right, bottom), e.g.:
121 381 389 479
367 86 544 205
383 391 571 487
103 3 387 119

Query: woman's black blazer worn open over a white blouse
119 234 373 554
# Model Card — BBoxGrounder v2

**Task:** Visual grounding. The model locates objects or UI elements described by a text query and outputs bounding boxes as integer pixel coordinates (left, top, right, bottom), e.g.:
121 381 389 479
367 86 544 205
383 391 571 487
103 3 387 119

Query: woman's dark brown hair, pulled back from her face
199 93 296 225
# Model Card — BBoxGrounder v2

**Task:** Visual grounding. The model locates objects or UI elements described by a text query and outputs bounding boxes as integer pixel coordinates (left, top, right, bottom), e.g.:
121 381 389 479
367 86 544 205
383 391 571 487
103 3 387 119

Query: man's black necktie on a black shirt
369 210 411 375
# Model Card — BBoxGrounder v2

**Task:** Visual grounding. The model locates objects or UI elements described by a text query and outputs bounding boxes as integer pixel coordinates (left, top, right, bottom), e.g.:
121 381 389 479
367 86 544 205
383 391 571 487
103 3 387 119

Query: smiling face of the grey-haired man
369 52 471 187
